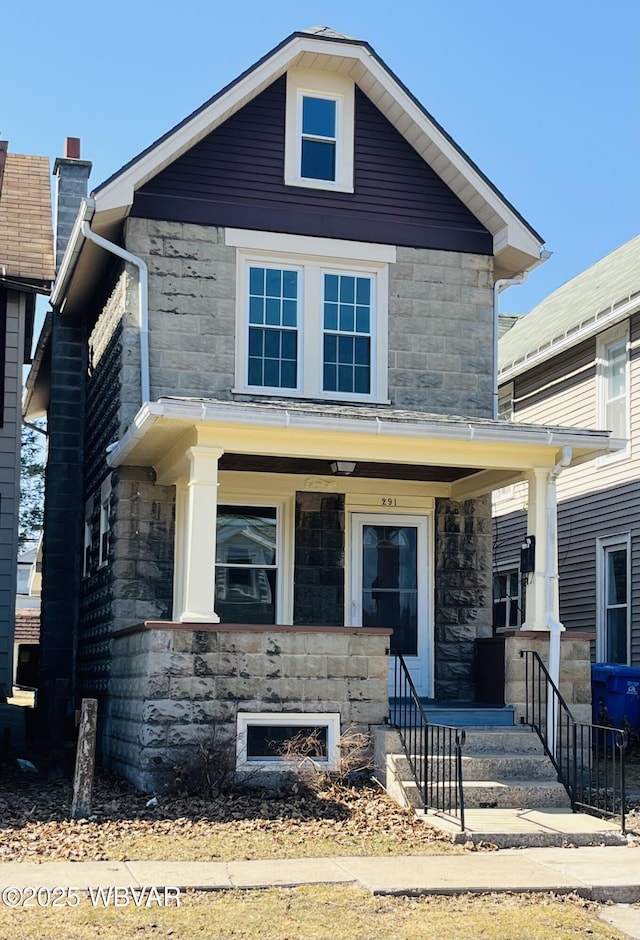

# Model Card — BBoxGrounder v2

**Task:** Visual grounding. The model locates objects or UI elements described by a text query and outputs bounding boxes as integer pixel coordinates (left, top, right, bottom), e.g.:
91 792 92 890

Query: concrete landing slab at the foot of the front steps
416 807 627 848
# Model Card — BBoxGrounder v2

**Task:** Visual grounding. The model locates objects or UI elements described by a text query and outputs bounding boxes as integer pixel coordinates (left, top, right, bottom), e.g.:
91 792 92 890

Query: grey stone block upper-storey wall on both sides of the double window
126 218 493 417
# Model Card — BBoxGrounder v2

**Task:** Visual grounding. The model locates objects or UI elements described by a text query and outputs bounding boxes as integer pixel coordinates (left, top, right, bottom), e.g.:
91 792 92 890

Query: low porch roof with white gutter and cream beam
108 398 626 499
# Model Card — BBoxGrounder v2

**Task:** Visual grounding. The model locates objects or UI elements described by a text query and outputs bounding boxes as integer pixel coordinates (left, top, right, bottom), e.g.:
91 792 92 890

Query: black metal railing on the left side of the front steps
390 653 465 831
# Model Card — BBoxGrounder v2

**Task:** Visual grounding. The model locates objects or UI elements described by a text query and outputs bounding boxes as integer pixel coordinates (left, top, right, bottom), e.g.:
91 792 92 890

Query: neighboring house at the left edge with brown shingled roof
0 141 54 701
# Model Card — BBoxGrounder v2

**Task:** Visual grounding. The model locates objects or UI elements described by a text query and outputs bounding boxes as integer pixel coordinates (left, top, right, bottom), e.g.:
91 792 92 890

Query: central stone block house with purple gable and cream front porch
27 27 612 788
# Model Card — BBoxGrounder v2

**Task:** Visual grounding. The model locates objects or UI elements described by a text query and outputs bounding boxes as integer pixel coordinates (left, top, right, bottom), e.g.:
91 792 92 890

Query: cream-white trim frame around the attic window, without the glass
284 69 355 193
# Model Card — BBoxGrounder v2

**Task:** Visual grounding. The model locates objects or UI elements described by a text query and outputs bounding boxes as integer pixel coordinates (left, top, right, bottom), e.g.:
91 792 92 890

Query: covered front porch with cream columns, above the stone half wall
109 398 616 698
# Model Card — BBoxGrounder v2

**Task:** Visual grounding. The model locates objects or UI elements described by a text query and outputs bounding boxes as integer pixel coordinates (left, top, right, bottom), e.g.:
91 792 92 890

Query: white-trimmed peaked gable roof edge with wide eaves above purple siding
92 27 543 277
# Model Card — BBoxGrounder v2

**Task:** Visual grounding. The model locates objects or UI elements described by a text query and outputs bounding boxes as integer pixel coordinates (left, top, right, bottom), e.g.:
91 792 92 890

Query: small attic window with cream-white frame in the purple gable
284 69 354 192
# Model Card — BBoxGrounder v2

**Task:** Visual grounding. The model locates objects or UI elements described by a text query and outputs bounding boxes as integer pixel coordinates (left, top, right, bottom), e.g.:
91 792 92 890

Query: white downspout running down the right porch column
544 447 573 755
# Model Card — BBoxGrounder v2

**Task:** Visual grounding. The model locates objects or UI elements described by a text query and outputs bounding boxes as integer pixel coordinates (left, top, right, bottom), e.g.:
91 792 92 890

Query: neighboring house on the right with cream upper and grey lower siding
494 236 640 666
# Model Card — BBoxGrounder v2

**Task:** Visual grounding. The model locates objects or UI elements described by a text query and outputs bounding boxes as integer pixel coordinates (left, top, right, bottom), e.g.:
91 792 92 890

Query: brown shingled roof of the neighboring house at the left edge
0 141 54 293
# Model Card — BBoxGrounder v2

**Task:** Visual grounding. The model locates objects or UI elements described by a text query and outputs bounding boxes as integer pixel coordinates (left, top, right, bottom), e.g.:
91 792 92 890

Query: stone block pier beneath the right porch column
504 630 593 723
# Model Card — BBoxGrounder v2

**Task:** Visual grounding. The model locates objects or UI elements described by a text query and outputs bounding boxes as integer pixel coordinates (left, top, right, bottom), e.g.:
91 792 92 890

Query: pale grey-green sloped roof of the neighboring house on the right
498 235 640 381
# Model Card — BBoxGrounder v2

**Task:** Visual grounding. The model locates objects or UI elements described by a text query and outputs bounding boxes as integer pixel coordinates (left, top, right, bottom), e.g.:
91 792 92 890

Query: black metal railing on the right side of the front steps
520 650 627 832
